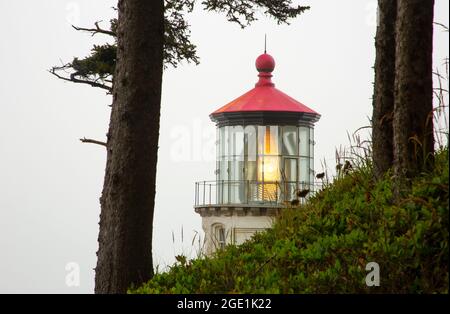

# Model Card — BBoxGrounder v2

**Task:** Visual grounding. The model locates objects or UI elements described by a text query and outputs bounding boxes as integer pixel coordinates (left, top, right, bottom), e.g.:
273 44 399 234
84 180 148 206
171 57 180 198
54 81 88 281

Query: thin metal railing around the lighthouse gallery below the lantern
194 180 322 207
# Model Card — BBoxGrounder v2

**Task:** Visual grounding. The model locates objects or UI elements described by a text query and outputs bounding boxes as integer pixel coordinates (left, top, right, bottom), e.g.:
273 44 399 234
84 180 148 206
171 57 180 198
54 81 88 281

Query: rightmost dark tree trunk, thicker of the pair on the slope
394 0 434 194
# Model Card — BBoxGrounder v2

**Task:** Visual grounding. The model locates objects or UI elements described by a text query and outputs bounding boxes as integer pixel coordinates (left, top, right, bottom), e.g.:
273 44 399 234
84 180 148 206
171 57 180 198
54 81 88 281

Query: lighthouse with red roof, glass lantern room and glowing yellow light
194 53 320 254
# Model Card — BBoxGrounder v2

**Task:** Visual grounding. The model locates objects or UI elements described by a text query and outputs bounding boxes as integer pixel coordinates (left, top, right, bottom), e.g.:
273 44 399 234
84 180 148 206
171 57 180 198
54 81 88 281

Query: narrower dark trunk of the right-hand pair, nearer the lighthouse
372 0 397 178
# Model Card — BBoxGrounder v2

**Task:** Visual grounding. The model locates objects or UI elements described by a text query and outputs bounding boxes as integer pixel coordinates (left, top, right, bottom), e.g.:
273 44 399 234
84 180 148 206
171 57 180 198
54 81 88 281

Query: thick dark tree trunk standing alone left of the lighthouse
95 0 164 293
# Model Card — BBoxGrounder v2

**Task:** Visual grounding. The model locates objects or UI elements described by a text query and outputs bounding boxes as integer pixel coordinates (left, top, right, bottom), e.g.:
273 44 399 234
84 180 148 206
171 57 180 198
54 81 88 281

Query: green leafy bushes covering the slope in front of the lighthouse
129 149 449 293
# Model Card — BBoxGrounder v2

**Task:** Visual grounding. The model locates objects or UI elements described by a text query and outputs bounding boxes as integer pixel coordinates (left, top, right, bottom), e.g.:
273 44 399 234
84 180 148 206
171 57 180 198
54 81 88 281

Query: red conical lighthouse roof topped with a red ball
211 53 319 116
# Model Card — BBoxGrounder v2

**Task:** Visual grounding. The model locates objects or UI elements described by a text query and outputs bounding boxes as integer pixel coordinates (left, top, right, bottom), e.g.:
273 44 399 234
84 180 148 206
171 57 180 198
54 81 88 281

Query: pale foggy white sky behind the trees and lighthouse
0 0 449 293
